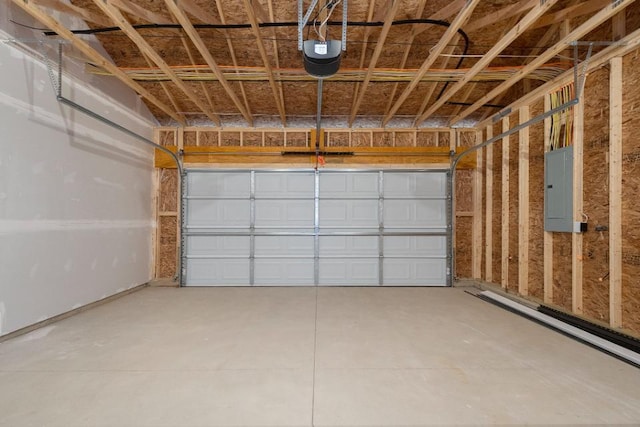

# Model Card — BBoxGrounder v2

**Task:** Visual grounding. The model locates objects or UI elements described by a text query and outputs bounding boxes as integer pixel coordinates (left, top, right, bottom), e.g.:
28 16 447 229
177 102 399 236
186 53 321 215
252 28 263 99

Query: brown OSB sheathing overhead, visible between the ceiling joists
66 0 537 121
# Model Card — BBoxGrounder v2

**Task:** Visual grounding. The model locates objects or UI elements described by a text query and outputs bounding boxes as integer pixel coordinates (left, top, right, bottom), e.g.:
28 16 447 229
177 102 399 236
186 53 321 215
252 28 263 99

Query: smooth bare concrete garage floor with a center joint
0 288 640 427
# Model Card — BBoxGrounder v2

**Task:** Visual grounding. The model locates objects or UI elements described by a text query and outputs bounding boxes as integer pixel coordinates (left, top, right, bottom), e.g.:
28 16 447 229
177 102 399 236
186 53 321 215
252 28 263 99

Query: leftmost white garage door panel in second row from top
187 200 251 228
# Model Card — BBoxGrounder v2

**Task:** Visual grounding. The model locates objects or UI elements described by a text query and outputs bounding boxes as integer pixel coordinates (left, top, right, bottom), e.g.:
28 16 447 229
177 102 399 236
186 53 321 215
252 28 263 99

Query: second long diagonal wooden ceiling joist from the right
415 0 558 125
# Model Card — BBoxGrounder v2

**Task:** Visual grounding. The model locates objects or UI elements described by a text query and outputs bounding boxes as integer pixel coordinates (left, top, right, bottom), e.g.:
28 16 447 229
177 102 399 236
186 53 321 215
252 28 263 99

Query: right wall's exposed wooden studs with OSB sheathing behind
470 33 640 337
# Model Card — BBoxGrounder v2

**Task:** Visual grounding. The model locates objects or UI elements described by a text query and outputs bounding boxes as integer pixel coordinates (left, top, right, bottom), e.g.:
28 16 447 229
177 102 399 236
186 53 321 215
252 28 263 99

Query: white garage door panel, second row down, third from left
320 199 379 228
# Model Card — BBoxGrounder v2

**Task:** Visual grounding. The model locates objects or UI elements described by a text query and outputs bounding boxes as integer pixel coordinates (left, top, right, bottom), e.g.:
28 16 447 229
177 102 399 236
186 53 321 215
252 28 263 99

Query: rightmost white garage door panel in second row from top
384 199 447 229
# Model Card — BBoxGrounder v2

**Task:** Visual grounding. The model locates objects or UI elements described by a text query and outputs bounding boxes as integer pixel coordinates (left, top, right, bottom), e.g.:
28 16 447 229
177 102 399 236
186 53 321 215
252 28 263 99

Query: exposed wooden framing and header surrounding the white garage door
154 127 483 284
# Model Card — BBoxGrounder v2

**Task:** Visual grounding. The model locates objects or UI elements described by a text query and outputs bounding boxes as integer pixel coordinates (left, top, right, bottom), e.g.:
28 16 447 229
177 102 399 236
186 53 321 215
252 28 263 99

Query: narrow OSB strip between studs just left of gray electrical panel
528 98 544 300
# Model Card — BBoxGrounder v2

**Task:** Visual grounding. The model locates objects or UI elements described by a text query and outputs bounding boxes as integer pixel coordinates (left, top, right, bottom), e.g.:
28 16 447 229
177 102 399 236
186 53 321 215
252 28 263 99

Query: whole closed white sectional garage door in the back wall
182 170 450 286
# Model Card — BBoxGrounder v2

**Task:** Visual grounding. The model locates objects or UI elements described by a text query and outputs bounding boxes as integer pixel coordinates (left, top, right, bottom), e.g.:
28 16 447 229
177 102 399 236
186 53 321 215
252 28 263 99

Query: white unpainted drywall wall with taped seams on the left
0 3 159 335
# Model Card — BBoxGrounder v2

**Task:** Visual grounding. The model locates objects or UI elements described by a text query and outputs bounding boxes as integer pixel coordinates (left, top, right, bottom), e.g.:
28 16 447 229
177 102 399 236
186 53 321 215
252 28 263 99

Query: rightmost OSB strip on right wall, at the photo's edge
622 50 640 333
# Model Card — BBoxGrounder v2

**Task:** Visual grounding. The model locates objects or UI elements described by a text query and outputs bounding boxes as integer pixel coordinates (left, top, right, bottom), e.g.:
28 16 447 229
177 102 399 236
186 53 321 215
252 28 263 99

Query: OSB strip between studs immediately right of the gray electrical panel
582 68 609 322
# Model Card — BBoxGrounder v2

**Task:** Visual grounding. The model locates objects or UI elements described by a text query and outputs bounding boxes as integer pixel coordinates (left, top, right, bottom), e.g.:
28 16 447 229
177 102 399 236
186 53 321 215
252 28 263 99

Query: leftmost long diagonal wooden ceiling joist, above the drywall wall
13 0 186 125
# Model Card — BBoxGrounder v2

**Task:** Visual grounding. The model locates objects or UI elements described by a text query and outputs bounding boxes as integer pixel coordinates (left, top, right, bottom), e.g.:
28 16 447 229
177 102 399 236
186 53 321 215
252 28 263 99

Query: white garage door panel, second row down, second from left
255 200 315 228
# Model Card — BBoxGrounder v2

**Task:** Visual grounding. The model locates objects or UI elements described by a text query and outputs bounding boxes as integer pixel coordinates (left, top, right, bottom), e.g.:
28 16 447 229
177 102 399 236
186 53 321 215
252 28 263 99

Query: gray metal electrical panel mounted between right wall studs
544 146 574 233
